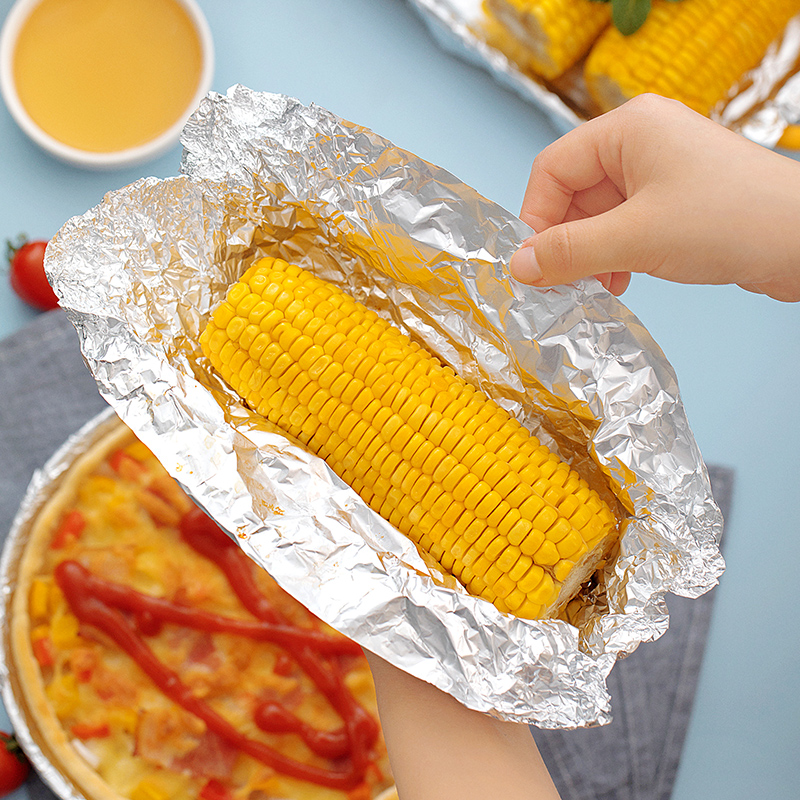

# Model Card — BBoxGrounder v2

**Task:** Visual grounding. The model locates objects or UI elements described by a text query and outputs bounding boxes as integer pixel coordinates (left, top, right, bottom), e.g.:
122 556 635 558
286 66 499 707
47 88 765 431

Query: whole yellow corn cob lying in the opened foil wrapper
200 258 615 618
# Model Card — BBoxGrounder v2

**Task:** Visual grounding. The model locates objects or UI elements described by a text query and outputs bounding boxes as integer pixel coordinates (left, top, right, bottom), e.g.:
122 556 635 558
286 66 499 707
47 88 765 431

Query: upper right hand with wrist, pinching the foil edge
511 95 800 301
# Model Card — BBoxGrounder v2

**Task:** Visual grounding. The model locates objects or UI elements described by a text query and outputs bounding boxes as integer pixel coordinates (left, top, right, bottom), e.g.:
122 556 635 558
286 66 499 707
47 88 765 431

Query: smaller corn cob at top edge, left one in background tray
484 0 611 80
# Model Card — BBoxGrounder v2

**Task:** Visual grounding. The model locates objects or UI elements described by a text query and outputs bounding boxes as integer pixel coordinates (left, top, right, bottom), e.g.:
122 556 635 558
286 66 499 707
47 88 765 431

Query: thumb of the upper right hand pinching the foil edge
509 200 650 286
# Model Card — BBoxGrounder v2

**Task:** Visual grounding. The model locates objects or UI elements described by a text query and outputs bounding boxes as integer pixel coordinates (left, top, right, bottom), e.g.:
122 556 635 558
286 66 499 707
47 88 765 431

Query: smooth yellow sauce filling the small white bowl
12 0 204 153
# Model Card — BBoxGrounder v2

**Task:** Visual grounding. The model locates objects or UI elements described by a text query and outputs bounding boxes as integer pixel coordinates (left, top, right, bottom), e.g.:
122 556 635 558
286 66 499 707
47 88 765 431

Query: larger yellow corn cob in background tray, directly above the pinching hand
584 0 800 116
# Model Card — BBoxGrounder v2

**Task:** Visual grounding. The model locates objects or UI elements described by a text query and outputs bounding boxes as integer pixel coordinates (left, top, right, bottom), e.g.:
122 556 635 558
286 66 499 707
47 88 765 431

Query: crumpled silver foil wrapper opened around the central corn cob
46 86 723 727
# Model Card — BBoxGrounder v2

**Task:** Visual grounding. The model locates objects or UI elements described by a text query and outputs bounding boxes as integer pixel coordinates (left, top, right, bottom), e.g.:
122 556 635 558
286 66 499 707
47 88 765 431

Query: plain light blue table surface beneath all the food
0 0 800 800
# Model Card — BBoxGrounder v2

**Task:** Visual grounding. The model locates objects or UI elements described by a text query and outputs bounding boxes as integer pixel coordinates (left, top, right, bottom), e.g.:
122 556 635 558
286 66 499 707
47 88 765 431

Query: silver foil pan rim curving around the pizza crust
0 409 119 800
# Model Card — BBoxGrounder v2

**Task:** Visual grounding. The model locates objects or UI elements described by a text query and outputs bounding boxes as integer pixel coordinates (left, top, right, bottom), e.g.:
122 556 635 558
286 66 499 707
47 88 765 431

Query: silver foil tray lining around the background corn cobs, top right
409 0 800 147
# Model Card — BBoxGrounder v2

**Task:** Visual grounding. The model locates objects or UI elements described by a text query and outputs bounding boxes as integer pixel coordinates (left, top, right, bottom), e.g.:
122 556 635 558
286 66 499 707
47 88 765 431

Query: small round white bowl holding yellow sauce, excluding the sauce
0 0 214 170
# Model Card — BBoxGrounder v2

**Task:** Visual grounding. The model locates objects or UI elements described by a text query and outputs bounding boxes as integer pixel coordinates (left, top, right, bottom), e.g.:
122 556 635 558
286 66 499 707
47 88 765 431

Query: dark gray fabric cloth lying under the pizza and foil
0 311 733 800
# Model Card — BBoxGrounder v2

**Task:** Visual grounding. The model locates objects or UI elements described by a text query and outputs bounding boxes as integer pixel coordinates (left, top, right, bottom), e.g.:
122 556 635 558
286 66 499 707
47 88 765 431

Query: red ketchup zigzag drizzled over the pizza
55 509 378 791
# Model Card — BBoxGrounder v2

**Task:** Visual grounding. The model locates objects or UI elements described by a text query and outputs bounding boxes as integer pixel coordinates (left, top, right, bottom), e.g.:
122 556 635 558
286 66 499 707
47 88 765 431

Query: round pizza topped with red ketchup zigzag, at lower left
9 424 392 800
